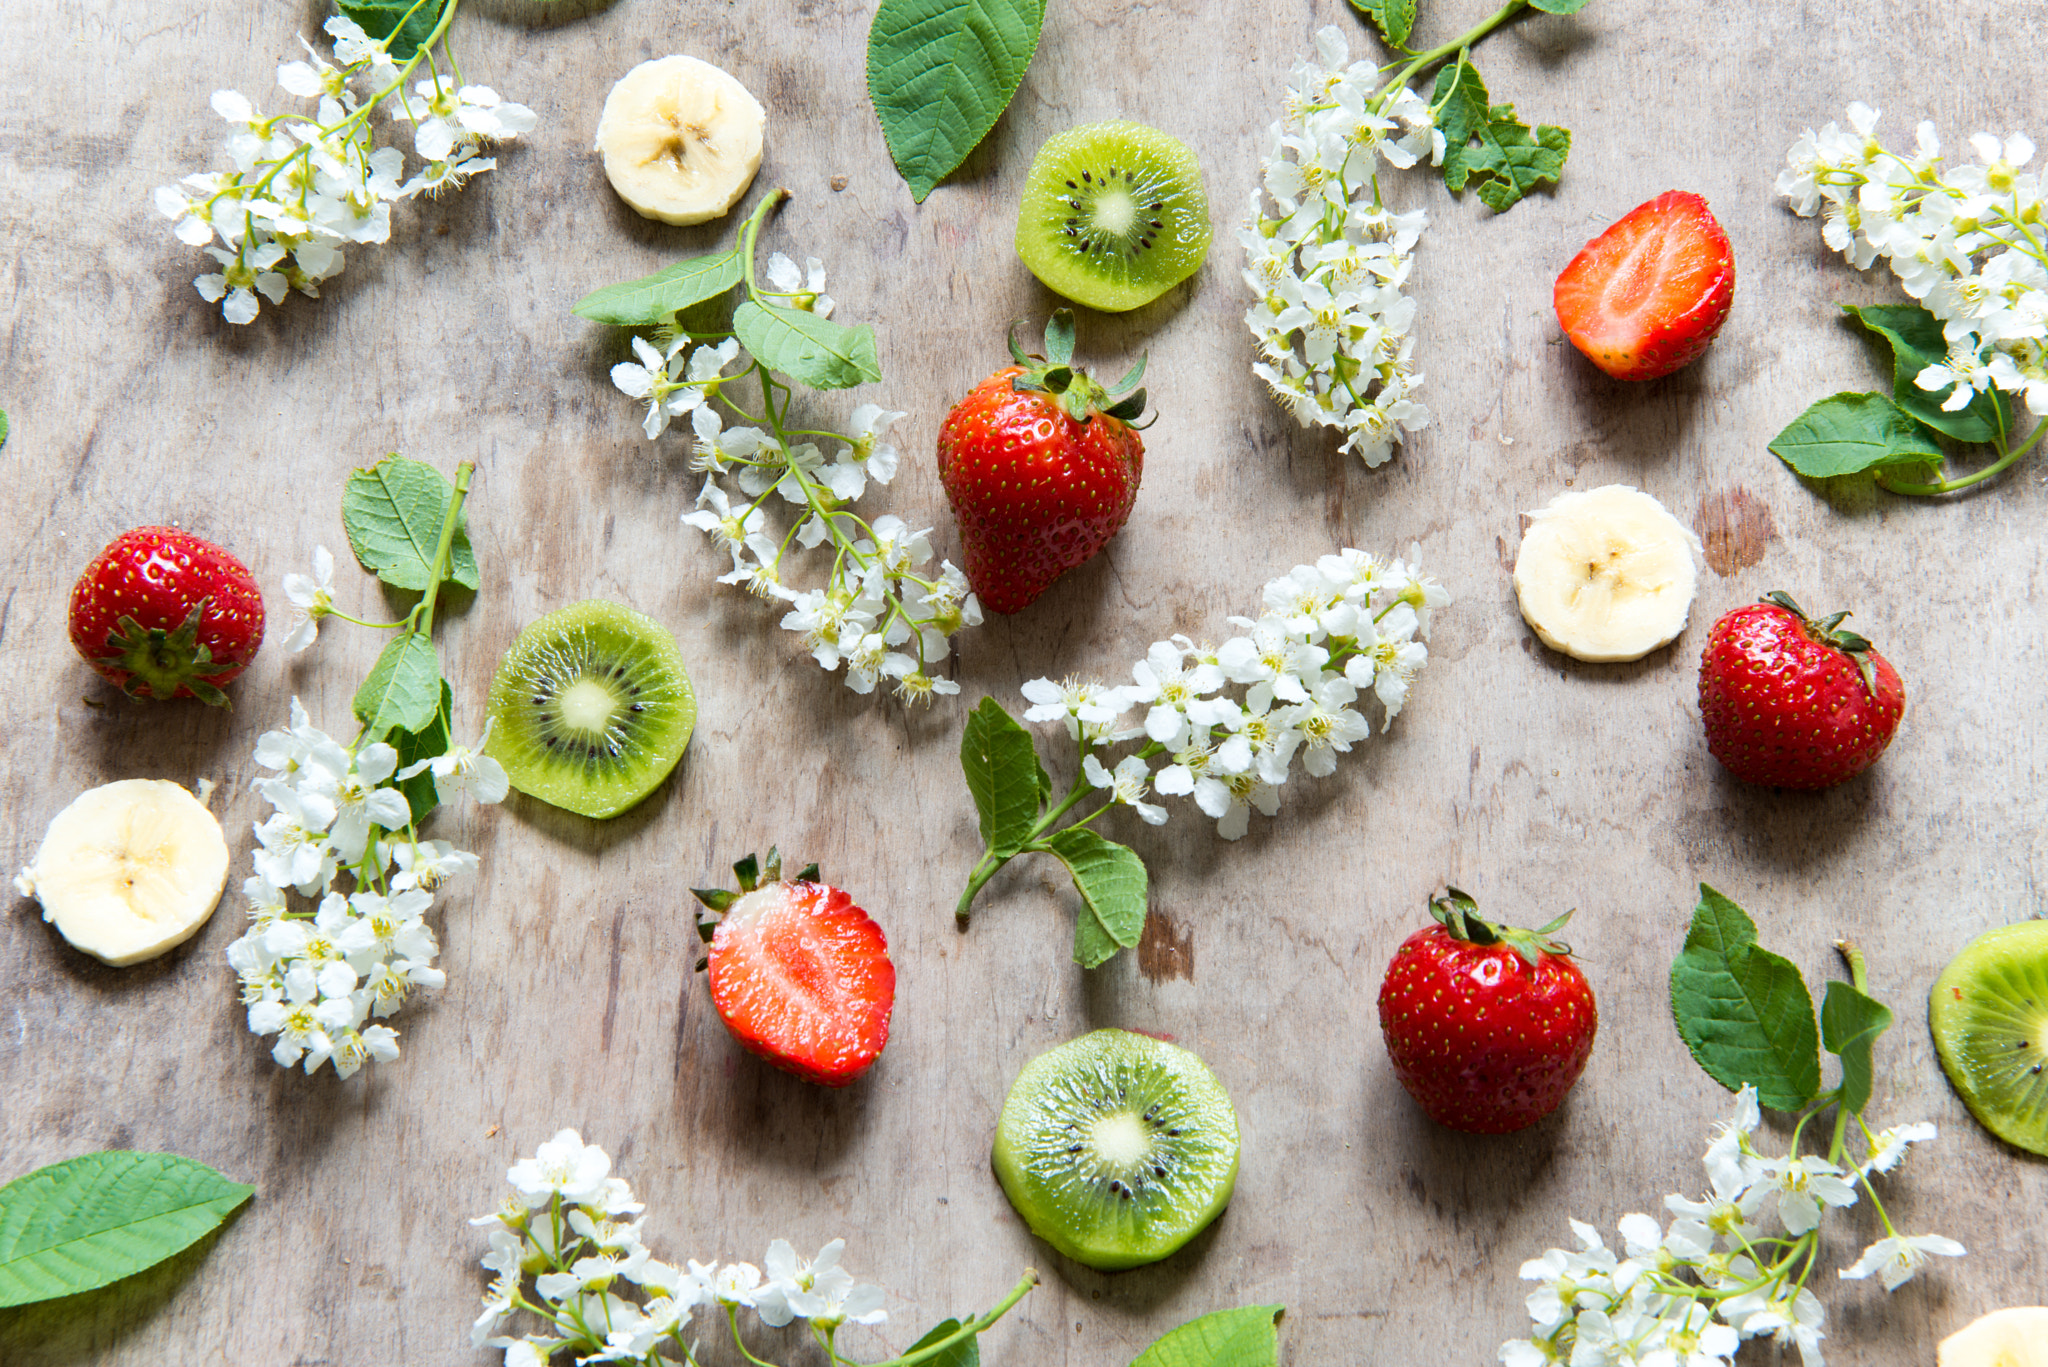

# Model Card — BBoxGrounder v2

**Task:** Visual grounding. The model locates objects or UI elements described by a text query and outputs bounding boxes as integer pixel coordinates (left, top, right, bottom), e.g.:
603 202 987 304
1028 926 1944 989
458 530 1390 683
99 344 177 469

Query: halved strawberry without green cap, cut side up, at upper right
1550 191 1735 379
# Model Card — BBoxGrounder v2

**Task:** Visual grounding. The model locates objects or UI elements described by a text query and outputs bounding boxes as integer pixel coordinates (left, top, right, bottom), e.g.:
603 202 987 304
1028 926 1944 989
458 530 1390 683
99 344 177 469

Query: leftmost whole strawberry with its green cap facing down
72 527 262 707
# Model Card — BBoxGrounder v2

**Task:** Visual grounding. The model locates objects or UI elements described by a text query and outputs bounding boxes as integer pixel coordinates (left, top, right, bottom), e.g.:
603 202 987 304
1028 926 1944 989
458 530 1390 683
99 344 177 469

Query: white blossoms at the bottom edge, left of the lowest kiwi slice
469 1129 889 1367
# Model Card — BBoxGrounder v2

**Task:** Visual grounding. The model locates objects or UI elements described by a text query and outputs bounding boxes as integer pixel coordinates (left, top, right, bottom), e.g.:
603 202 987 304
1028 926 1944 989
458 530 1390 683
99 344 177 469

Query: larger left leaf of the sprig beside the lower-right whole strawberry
1671 883 1821 1111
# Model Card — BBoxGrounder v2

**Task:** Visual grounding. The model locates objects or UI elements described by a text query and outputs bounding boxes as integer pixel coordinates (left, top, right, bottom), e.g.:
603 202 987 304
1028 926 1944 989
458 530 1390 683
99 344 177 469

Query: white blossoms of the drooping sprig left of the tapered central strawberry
612 266 981 703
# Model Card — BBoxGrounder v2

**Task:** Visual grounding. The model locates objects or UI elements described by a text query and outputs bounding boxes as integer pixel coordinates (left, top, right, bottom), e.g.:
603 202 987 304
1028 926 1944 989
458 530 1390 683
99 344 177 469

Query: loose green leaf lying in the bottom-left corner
0 1150 256 1306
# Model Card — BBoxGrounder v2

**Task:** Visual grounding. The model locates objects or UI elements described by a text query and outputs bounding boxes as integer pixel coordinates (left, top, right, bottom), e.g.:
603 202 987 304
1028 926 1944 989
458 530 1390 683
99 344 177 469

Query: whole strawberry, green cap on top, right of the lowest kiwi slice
1380 887 1599 1135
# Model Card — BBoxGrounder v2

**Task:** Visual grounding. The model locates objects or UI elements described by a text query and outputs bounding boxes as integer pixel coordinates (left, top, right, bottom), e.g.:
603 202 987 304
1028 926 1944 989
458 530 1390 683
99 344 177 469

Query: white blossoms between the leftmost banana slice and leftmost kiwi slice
227 699 508 1078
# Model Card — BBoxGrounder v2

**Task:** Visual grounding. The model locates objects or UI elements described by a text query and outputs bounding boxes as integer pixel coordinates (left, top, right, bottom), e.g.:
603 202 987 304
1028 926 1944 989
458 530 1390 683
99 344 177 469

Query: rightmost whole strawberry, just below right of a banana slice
1700 590 1907 789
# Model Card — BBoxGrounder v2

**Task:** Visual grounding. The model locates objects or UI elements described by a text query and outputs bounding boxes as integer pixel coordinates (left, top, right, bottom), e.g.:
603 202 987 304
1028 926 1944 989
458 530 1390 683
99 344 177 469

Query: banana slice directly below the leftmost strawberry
14 779 227 967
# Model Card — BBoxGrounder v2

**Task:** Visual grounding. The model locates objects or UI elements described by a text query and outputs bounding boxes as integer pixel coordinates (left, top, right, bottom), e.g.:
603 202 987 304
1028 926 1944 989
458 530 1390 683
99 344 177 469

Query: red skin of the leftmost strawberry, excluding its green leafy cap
70 527 264 697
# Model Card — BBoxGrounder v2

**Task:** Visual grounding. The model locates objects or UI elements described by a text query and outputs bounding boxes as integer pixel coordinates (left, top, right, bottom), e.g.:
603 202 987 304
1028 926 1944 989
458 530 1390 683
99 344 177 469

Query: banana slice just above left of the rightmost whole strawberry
1516 484 1702 662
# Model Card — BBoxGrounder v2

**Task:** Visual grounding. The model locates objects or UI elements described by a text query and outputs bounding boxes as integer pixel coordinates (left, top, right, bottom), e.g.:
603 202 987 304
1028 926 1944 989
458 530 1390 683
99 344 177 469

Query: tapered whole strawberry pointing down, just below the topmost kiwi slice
938 309 1145 613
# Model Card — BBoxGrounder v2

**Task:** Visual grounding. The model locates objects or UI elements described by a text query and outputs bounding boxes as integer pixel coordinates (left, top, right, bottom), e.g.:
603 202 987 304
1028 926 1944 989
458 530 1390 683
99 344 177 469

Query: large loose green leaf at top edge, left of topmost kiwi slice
868 0 1044 205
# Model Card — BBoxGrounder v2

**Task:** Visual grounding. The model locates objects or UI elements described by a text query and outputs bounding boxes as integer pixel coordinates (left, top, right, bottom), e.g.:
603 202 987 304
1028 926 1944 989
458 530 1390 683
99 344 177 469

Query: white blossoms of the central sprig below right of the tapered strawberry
1024 547 1450 840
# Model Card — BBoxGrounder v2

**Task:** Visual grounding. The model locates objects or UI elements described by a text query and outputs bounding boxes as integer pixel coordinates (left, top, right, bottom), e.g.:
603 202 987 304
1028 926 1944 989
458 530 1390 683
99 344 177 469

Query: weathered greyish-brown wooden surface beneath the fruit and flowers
0 0 2048 1367
